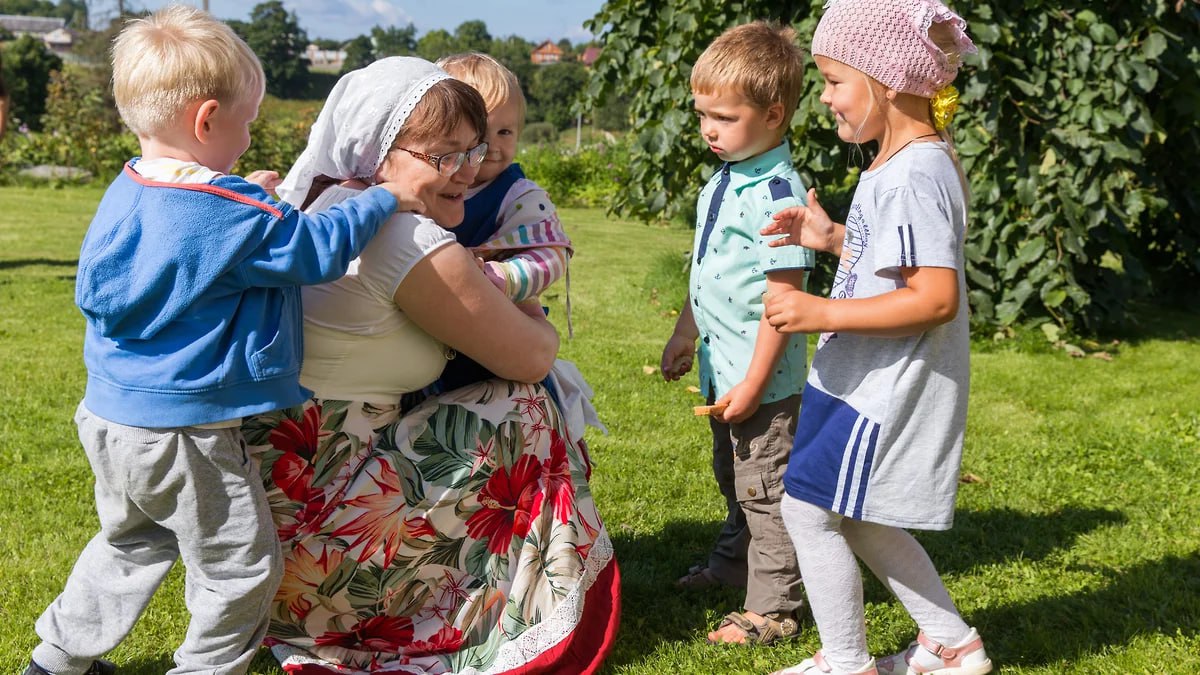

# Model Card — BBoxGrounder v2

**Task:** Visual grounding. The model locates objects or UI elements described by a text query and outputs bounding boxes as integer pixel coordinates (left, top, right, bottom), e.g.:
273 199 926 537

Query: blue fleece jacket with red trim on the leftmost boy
76 165 396 428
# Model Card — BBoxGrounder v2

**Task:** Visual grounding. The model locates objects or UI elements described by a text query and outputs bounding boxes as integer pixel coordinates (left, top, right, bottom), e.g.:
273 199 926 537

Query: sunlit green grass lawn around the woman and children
0 187 1200 675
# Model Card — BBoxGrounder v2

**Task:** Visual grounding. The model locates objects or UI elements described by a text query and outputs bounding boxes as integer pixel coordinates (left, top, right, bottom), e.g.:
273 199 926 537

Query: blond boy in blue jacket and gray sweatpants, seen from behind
25 5 417 675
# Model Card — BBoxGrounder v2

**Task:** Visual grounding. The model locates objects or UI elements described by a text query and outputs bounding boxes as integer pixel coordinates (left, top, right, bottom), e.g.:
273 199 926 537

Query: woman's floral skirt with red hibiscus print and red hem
242 380 619 674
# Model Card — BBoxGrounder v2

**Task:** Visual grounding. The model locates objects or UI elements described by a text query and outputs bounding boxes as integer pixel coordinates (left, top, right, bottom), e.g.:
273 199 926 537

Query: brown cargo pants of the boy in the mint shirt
708 395 804 615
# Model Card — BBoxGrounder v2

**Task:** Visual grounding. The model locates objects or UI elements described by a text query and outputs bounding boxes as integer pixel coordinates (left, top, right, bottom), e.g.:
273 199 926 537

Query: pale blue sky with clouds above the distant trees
120 0 604 42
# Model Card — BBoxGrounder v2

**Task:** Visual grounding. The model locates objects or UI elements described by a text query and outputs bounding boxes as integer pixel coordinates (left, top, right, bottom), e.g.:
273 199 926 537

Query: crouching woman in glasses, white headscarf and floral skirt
244 58 619 674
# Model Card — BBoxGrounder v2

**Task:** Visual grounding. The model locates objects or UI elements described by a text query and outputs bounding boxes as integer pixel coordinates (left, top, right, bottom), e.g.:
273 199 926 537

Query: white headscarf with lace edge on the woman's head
276 56 450 207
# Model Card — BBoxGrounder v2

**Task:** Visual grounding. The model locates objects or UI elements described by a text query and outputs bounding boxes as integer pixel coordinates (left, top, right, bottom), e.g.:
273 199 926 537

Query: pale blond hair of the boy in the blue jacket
113 5 266 137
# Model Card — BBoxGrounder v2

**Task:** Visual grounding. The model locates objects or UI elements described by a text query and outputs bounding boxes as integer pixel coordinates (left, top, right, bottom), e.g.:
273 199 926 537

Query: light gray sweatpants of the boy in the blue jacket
34 404 282 675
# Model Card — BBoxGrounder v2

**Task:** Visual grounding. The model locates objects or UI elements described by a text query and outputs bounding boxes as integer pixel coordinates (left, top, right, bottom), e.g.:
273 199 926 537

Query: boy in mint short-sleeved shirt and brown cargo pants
661 22 812 644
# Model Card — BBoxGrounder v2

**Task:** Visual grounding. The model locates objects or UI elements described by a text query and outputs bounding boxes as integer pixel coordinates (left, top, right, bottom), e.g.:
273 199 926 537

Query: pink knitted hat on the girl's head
812 0 976 98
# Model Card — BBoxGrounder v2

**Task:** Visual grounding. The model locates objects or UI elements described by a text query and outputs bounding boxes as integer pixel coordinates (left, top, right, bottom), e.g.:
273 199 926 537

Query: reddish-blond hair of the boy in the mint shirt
691 22 804 121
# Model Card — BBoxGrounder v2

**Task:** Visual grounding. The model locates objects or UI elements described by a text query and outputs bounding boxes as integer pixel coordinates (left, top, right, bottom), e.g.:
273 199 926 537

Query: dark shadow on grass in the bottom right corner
966 552 1200 671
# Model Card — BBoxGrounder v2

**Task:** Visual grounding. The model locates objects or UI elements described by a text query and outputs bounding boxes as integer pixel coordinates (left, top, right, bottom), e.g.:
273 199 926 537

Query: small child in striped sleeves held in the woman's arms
434 53 572 390
